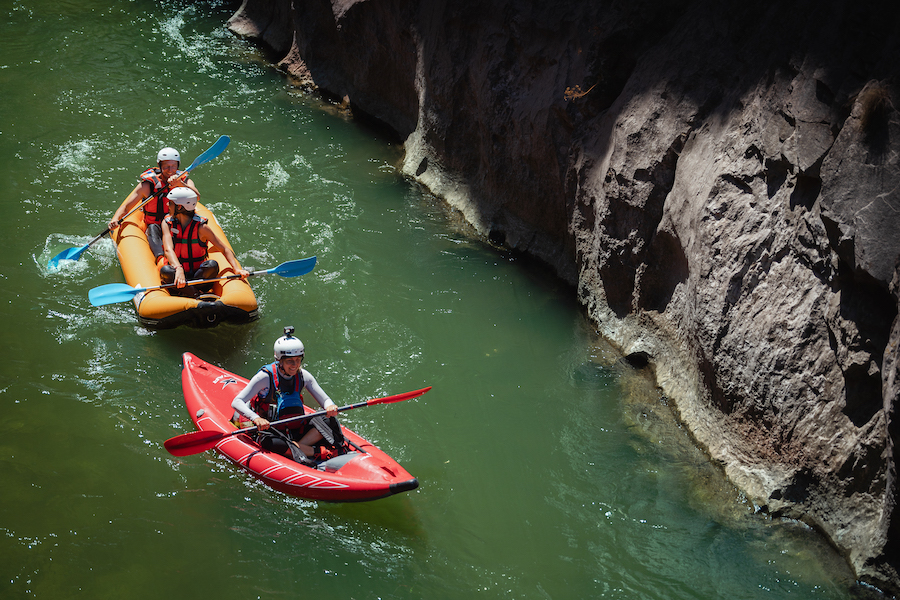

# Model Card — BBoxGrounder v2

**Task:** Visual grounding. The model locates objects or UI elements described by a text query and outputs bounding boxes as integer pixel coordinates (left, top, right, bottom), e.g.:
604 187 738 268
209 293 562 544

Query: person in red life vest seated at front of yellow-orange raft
159 187 250 295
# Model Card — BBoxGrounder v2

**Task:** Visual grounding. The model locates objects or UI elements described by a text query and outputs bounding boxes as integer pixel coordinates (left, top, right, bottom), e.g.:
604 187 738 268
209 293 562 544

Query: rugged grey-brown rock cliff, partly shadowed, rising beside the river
229 0 900 594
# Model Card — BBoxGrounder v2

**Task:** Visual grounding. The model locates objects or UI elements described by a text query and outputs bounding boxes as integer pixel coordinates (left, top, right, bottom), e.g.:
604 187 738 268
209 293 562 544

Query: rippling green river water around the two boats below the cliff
0 0 867 600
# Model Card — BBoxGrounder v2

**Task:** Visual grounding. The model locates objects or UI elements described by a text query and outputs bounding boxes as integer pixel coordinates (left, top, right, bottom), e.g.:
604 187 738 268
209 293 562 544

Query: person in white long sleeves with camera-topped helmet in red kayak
231 327 344 462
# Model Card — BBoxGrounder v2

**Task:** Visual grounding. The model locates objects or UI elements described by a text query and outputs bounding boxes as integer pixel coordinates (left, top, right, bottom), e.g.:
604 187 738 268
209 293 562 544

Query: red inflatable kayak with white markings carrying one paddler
181 352 430 502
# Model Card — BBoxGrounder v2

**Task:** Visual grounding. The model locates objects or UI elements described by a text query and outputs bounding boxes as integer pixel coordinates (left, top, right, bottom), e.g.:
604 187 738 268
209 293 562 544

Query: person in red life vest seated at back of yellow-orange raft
109 147 200 262
